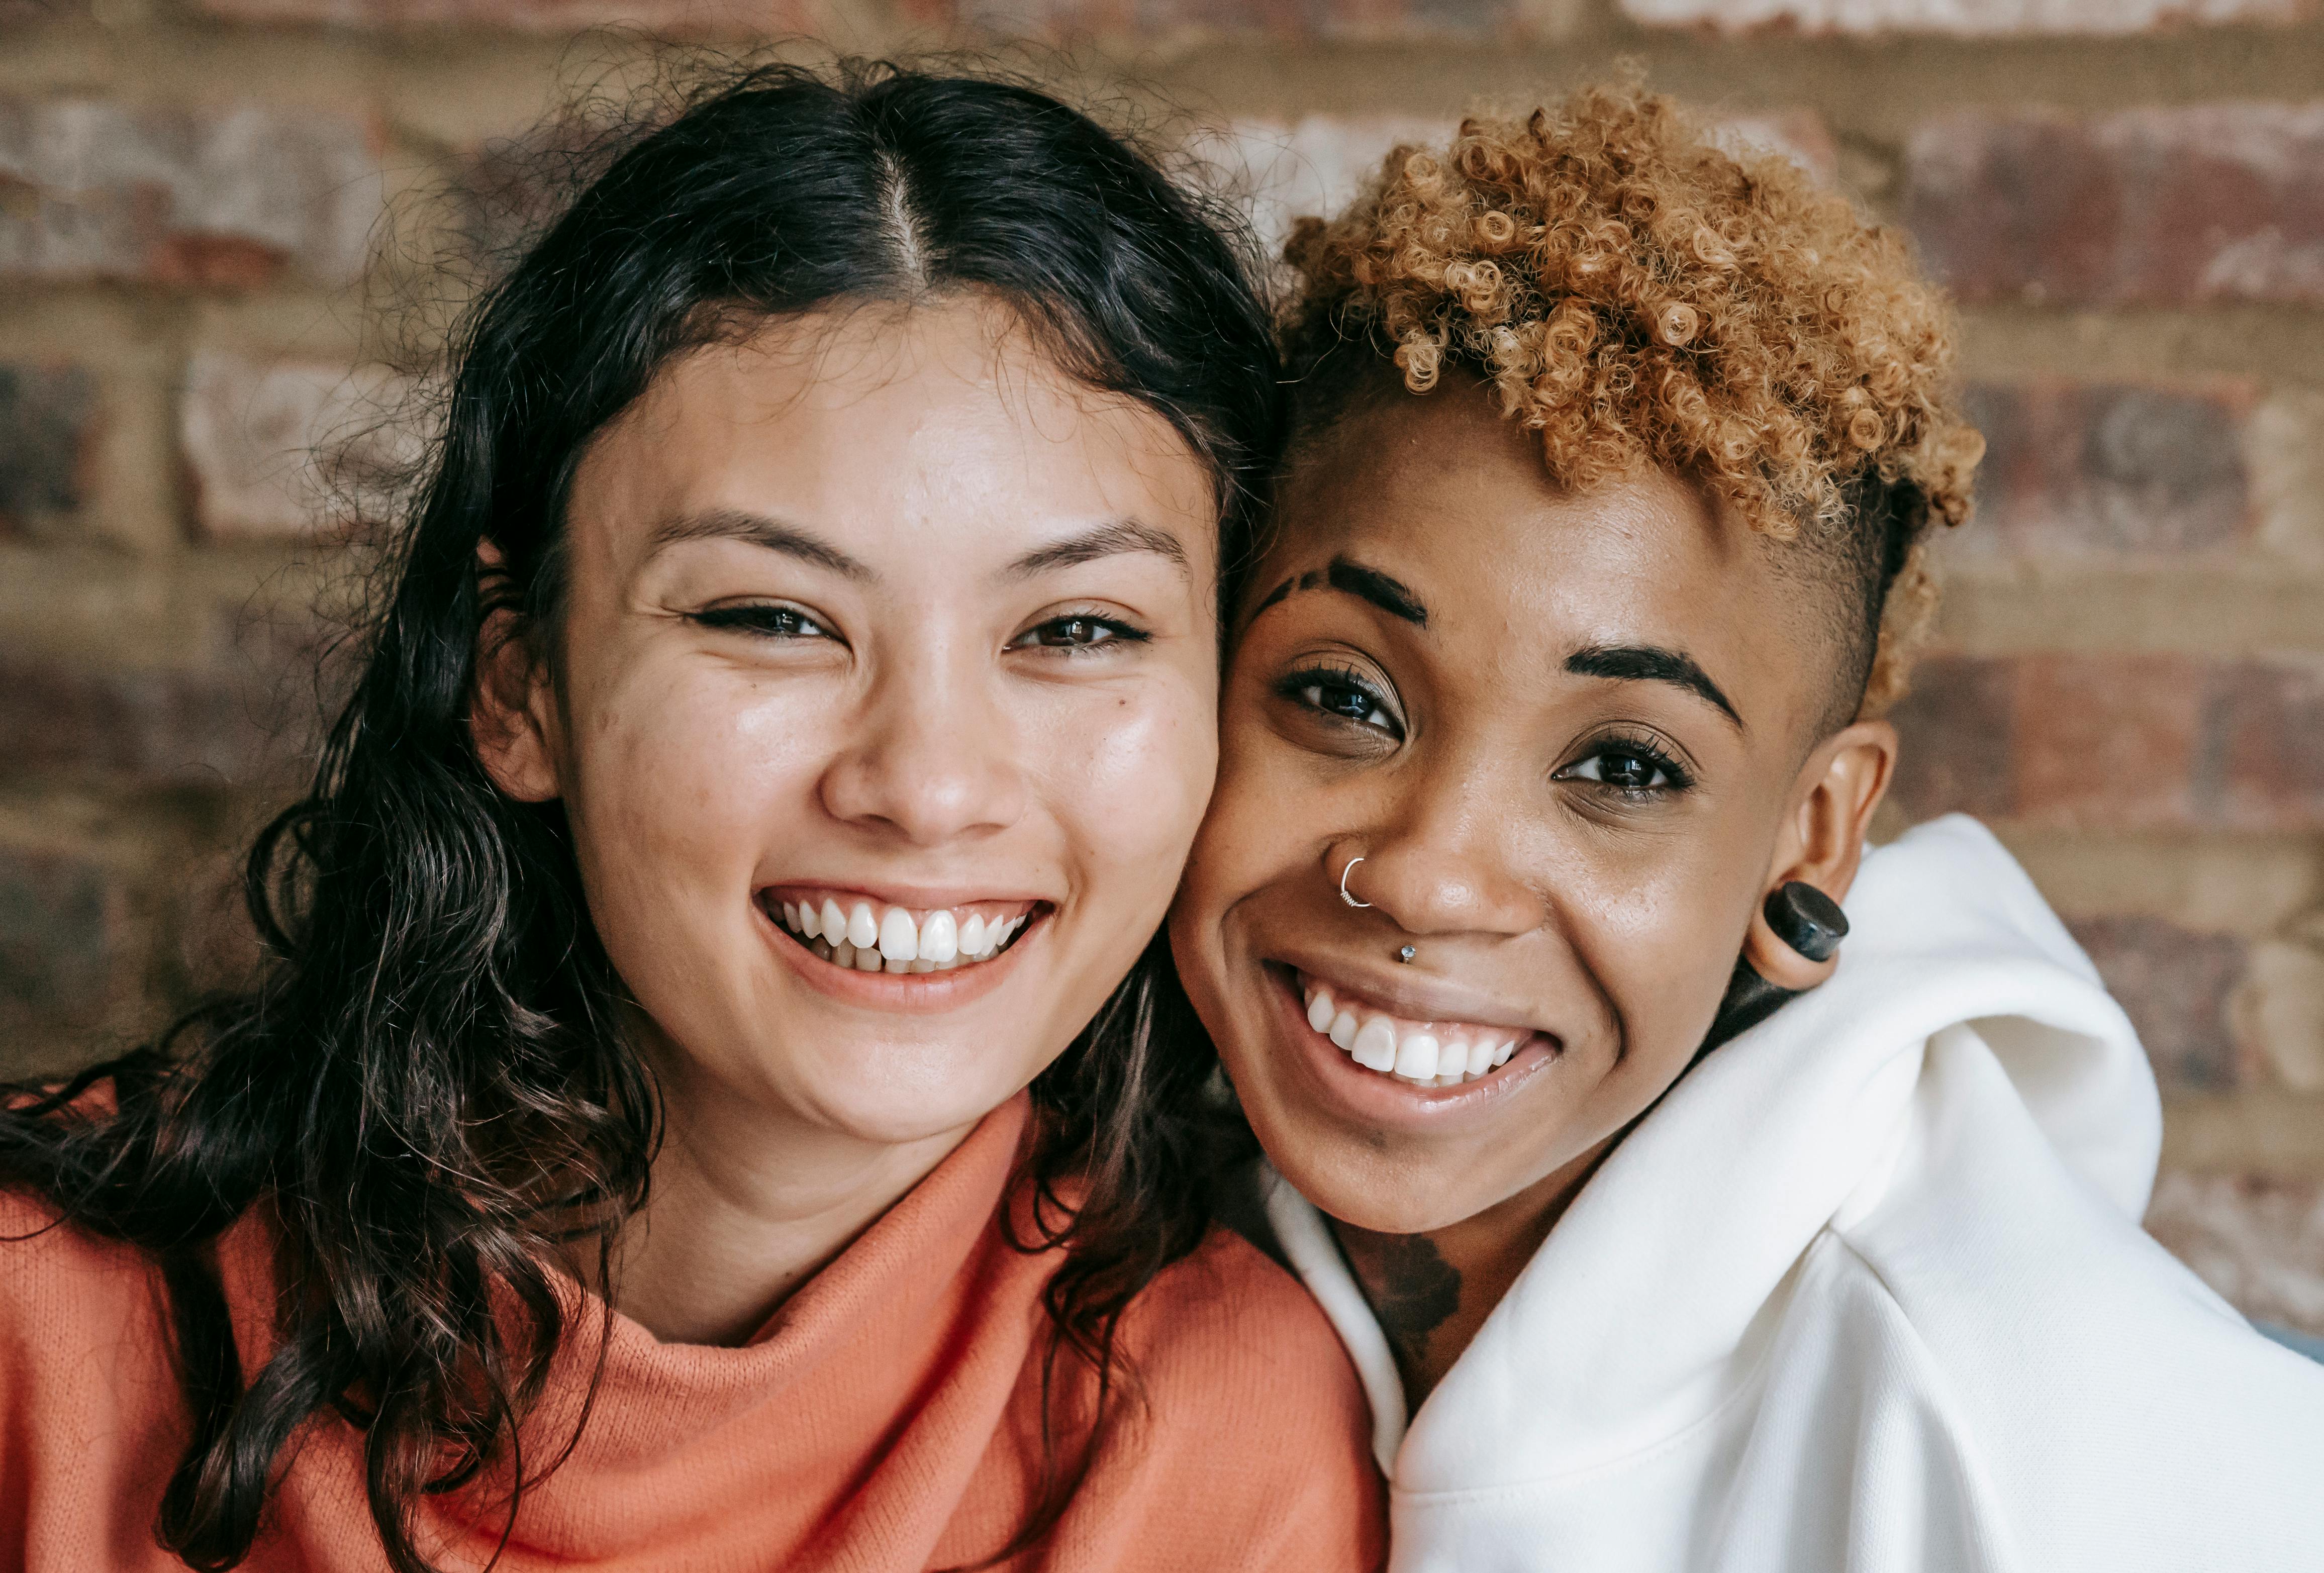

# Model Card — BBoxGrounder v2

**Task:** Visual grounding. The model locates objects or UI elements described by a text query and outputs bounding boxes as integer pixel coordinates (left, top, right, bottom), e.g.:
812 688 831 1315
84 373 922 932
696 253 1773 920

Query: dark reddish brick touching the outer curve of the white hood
2066 918 2250 1092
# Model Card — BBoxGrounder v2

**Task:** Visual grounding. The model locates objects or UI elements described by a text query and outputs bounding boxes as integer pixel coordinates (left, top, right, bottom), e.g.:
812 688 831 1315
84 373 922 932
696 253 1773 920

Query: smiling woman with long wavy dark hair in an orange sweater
0 67 1378 1573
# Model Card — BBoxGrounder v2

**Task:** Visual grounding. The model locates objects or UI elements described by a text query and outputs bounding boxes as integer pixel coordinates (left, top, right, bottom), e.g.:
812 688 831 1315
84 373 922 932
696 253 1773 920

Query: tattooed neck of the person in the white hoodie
1332 1141 1613 1413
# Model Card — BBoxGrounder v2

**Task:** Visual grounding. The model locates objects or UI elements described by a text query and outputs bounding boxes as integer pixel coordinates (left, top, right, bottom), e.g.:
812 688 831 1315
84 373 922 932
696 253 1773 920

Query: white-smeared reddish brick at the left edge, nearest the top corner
0 100 381 288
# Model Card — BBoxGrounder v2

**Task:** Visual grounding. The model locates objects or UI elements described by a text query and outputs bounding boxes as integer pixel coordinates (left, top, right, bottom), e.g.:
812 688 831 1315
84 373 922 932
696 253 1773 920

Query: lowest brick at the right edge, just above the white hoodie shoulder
2148 1173 2324 1334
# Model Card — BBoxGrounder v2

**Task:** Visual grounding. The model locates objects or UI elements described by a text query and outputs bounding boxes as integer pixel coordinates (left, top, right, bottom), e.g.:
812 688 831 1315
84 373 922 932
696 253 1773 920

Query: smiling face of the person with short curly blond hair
1171 374 1894 1234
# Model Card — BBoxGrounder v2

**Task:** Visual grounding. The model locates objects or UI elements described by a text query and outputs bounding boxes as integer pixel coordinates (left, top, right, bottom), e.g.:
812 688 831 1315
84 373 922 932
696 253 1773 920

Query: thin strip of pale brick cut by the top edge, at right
1622 0 2308 37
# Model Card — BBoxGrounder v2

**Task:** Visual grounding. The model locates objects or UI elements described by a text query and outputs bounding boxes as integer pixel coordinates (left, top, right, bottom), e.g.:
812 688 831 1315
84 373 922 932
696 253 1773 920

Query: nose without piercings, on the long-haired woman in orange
820 655 1025 846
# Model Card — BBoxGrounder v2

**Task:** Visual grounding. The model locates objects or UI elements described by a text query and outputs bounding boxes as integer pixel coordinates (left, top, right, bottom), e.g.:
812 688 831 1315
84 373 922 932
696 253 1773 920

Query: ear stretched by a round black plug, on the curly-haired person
1743 720 1896 990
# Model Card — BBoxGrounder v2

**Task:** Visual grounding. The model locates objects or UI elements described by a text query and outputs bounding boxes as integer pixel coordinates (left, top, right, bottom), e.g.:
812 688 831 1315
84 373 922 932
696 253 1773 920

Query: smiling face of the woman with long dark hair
479 298 1218 1145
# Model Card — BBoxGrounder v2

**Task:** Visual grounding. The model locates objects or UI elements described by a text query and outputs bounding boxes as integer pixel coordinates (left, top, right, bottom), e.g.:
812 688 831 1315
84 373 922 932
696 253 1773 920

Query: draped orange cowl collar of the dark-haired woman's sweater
254 1095 1055 1568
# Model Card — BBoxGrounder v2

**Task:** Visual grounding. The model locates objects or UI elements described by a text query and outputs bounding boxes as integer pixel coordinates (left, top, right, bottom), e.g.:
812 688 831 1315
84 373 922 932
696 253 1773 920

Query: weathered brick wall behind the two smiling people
0 0 2324 1331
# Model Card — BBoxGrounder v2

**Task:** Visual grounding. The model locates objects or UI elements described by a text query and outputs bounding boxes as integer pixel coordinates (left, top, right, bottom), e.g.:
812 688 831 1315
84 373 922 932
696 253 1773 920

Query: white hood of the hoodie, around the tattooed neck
1269 816 2161 1494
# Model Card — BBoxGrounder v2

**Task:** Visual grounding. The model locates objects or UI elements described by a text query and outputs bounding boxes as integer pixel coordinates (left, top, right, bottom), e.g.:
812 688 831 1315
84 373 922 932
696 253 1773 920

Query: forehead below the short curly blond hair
1257 383 1820 730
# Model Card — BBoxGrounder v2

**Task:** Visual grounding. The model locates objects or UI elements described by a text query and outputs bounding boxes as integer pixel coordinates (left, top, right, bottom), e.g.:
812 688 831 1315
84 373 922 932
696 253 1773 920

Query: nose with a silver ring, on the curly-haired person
1325 757 1548 936
